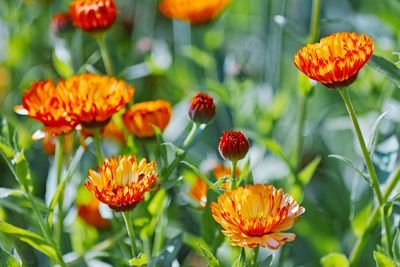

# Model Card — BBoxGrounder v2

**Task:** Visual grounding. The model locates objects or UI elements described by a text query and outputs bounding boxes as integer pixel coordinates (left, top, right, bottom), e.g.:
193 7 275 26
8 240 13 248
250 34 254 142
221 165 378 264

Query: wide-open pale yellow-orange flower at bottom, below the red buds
210 184 304 249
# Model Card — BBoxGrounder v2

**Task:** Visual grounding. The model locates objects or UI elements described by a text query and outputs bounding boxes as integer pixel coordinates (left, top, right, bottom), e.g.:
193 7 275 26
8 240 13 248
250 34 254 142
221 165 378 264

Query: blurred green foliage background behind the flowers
0 0 400 266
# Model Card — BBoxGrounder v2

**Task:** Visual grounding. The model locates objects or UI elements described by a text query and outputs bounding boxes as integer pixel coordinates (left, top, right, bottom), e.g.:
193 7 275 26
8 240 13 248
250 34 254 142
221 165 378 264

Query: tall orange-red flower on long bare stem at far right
294 32 374 88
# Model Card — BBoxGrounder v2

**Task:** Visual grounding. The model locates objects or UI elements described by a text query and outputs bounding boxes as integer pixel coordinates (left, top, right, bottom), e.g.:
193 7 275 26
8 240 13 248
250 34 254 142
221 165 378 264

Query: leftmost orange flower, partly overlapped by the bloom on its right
14 80 79 135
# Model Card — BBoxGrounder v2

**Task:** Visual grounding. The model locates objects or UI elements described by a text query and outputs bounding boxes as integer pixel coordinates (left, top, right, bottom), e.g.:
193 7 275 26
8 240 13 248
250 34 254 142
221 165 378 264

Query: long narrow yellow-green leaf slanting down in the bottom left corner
0 221 59 262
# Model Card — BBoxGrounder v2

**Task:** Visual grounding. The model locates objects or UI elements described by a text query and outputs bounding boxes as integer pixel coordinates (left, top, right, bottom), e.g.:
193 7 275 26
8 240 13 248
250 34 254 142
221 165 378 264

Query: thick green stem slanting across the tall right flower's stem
350 167 400 266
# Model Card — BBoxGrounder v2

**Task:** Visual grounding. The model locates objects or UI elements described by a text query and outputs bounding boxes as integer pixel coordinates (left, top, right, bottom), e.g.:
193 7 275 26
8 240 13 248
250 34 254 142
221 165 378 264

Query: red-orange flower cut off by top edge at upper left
69 0 117 32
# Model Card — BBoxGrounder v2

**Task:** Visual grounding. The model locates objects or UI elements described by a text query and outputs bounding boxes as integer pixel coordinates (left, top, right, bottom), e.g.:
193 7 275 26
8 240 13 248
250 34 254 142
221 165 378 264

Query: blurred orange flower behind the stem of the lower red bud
189 164 240 208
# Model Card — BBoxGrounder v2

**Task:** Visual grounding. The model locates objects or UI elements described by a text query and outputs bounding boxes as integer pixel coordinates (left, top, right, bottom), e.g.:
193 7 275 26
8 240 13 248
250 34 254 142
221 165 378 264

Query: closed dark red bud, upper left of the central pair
189 93 215 124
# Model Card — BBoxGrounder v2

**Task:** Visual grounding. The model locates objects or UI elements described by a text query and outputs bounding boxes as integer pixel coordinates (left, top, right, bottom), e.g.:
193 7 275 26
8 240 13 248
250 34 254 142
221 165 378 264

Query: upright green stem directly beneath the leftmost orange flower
54 135 65 251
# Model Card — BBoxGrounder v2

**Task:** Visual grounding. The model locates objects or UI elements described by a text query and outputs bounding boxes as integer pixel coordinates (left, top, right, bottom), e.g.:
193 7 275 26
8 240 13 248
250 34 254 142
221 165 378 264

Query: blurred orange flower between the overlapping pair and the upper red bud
122 100 172 137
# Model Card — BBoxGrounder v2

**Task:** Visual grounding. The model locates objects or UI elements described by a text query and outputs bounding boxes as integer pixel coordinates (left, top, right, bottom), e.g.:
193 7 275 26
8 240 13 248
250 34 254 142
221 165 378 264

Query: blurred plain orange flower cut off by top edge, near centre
159 0 231 24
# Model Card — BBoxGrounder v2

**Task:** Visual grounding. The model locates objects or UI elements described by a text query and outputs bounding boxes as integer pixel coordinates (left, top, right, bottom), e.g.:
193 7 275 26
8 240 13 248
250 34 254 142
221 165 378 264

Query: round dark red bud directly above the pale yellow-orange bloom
218 131 249 161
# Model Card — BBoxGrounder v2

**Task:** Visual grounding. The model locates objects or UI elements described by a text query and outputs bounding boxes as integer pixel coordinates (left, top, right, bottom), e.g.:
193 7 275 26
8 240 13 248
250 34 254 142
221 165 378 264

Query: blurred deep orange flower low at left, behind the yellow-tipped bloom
78 195 111 229
